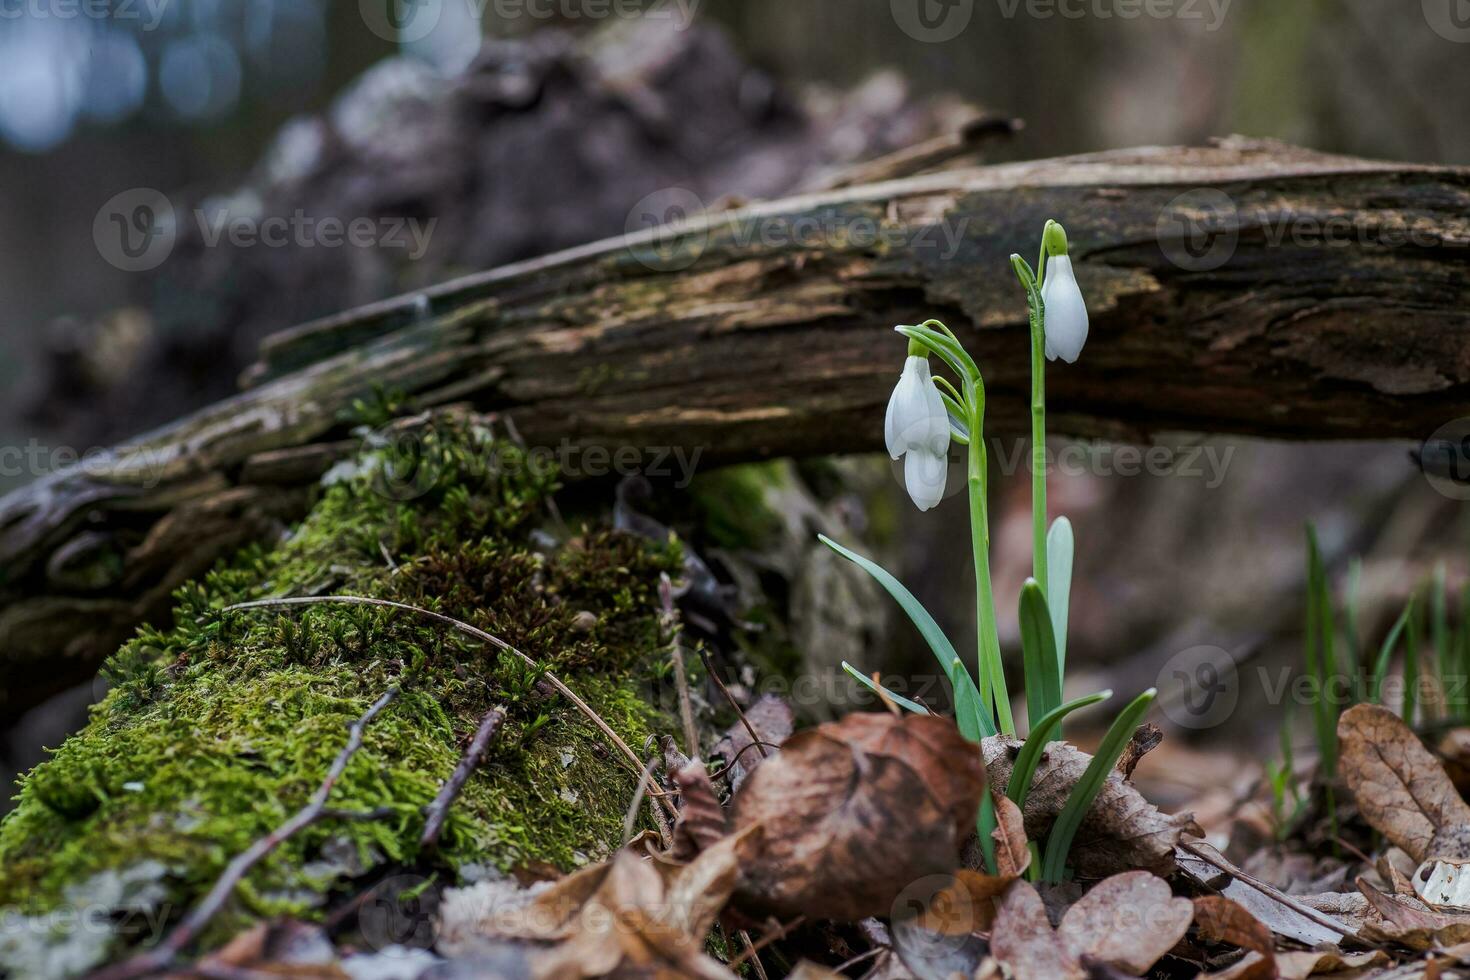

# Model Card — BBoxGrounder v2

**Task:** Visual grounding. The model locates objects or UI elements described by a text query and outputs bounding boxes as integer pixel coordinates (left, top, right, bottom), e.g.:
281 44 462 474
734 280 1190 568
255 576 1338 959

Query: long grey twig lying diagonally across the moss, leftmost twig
91 688 398 980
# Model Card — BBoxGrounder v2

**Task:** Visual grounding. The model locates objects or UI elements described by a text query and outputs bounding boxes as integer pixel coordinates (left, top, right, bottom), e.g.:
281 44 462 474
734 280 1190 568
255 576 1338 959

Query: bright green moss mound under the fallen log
0 422 679 957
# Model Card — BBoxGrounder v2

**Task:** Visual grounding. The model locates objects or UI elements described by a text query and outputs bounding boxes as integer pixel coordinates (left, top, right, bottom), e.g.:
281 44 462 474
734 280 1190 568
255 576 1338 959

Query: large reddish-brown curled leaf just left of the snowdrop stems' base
732 714 985 920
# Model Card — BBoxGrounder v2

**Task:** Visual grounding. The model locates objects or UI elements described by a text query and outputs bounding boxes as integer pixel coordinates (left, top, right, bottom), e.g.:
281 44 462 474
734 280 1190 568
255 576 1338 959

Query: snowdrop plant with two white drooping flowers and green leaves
822 222 1154 880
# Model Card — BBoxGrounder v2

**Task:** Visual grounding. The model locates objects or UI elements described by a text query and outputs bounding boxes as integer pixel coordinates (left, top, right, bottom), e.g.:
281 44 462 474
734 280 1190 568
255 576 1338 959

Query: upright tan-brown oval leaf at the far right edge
1338 704 1470 861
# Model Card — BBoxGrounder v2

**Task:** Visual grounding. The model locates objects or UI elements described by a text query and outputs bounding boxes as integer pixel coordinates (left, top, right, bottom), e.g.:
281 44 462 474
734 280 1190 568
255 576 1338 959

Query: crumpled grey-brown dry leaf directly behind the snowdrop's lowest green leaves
983 736 1195 879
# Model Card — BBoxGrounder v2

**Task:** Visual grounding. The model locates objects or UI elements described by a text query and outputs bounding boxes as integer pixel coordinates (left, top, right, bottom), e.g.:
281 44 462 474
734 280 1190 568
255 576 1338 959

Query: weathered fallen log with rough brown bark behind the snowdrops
0 141 1470 710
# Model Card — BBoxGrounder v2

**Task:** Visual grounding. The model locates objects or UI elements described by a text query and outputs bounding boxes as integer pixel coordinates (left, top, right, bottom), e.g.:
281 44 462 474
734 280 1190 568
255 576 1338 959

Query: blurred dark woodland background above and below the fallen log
0 0 1470 811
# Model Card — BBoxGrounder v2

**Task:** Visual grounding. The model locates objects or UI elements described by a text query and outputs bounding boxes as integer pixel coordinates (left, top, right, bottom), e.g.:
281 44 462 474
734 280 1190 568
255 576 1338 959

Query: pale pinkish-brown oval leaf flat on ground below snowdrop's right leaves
1057 871 1194 976
